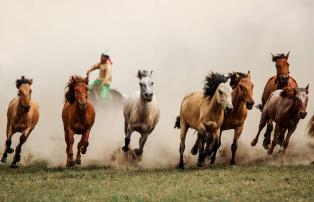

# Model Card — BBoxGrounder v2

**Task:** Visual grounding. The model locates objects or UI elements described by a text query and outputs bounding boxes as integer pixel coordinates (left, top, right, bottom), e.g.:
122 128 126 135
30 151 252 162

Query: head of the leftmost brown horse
16 76 33 112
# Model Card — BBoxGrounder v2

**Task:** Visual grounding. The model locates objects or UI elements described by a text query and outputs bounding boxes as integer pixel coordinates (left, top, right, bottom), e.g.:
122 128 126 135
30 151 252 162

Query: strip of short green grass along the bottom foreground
0 162 314 201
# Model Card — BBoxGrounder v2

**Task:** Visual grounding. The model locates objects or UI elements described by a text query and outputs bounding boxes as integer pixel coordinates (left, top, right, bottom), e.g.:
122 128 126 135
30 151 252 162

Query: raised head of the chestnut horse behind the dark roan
271 52 290 86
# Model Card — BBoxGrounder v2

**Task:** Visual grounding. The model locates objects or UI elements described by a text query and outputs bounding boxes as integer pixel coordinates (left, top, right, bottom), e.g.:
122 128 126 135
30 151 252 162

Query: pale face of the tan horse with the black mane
216 83 233 111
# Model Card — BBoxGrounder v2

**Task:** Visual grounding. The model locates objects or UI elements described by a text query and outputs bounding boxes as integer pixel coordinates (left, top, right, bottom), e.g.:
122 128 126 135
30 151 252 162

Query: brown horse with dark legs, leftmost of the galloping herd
1 76 39 167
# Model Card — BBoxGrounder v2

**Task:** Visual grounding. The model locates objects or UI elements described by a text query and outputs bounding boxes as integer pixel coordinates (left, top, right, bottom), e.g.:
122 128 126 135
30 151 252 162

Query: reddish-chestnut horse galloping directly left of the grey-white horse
62 76 95 166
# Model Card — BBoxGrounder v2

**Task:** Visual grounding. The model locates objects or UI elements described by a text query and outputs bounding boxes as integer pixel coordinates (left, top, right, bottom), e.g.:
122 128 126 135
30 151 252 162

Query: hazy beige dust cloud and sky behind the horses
0 0 314 167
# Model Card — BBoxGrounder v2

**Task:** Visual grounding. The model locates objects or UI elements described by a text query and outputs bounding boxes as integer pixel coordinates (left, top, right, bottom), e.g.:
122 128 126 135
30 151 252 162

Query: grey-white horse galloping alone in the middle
122 70 160 156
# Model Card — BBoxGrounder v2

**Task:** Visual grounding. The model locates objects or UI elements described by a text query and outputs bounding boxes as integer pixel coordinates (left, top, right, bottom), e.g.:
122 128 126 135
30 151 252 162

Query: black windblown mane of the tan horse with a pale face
203 72 228 98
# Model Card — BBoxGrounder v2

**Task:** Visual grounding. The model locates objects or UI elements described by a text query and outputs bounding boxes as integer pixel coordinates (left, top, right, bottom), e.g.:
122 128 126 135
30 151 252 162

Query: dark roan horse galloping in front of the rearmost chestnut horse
251 85 309 154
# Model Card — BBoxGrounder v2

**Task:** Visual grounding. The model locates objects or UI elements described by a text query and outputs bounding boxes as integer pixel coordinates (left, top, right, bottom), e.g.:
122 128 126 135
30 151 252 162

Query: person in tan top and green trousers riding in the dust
86 51 112 99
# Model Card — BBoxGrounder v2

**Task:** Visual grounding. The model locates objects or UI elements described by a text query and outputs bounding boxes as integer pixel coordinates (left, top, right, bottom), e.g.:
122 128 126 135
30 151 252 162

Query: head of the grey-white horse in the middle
137 70 154 102
